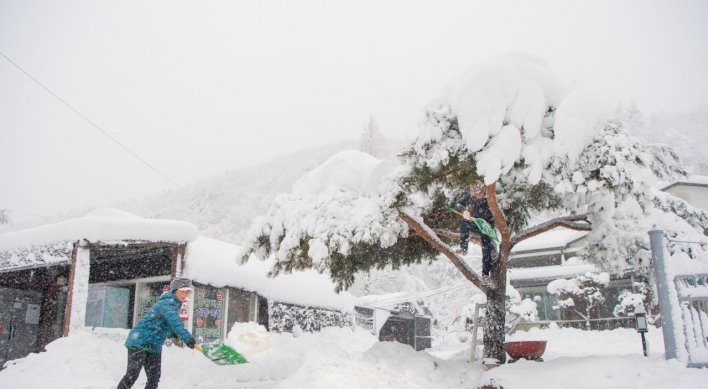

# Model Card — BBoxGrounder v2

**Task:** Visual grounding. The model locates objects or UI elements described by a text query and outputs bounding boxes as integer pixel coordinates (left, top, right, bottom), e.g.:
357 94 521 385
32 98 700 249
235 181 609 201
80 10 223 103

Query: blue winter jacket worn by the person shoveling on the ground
125 291 193 353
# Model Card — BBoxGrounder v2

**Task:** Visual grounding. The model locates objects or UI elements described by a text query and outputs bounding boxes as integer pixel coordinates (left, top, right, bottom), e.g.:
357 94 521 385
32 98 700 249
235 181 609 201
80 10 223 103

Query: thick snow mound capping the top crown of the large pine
418 54 612 185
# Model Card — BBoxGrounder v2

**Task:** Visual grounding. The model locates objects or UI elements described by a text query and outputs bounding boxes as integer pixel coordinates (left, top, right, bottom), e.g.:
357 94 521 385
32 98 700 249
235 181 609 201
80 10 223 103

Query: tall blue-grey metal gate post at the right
649 226 678 359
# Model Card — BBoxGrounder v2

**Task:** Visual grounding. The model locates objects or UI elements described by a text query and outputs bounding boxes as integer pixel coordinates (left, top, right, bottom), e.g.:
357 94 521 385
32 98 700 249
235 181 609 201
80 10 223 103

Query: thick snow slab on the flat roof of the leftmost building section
0 208 197 252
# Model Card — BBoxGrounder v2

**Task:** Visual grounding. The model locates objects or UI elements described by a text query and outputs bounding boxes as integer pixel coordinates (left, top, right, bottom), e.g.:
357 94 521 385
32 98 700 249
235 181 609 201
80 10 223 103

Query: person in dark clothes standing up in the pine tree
455 182 496 277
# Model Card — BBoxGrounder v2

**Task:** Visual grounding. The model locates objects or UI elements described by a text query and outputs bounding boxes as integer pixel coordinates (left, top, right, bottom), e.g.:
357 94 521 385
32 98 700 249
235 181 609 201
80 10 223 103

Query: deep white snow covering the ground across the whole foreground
0 325 708 389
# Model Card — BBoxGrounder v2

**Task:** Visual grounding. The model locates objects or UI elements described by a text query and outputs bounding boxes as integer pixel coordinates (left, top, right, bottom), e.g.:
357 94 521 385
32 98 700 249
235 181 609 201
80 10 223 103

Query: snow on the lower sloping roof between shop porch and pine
184 236 354 311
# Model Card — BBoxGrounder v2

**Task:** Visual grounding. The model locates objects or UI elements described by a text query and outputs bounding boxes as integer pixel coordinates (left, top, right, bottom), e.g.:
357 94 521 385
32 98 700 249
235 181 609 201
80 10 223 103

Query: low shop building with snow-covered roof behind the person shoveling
0 209 354 366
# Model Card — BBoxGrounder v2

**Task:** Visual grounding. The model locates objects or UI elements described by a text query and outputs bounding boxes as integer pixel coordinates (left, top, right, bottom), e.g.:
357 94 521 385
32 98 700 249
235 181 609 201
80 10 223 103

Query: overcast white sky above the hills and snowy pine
0 0 708 218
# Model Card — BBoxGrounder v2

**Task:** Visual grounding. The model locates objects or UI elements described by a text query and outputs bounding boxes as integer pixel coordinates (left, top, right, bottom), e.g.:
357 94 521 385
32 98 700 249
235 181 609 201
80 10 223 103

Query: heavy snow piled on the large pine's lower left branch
237 150 407 270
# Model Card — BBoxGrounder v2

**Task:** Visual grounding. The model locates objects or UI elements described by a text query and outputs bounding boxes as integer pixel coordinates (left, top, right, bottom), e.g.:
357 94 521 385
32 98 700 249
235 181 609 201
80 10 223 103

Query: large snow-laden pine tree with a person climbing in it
238 54 708 363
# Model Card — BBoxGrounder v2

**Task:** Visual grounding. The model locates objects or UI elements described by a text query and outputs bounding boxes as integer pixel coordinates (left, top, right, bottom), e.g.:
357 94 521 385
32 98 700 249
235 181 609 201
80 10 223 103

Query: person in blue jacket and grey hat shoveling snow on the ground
118 277 196 389
